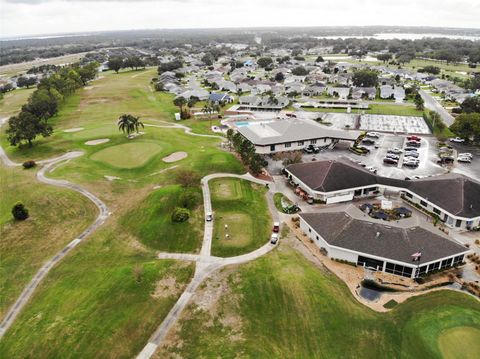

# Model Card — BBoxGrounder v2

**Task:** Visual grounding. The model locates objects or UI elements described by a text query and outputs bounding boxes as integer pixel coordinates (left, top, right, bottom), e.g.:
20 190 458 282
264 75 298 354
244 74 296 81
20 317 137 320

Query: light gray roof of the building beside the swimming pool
238 119 360 146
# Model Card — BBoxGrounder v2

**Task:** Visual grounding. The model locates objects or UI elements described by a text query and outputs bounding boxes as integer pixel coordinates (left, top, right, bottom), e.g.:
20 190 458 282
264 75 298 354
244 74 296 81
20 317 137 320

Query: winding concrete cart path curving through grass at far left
0 119 110 339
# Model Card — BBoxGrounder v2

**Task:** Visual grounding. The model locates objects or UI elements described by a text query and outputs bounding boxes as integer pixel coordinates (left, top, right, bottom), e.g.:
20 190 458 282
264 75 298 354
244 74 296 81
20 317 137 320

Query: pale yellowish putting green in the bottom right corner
438 327 480 359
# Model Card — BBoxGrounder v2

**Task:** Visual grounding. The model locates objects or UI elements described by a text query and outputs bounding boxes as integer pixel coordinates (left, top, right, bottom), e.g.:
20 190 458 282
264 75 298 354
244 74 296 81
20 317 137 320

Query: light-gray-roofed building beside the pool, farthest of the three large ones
238 119 360 154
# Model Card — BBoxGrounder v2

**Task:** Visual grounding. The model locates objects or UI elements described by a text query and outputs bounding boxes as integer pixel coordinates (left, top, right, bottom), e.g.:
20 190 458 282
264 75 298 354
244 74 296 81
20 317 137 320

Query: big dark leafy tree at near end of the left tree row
6 111 53 147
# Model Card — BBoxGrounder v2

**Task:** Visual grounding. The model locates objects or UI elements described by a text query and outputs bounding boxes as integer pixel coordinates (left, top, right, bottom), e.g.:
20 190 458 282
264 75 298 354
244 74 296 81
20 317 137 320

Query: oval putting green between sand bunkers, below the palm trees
90 142 162 168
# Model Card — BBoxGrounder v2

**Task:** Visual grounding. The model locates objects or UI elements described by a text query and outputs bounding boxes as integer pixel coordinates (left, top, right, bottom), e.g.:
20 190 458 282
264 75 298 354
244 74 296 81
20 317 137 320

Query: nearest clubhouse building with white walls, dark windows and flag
300 205 469 278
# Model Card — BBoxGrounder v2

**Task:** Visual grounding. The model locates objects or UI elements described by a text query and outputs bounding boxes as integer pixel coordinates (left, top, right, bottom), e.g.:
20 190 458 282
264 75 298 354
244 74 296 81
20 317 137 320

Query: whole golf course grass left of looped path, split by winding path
0 69 245 358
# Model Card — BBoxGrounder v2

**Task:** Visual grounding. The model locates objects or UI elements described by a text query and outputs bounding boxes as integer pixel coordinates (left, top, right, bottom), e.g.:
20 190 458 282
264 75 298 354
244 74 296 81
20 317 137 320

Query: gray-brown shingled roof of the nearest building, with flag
300 212 468 264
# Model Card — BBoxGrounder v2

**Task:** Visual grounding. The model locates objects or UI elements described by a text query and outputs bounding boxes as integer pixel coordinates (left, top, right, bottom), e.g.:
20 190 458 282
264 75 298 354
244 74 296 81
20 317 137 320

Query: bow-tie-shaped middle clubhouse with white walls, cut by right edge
285 160 480 229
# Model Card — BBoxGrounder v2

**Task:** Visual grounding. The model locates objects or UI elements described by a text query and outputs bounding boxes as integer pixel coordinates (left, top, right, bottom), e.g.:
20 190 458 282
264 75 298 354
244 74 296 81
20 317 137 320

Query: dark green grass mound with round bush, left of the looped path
122 185 204 253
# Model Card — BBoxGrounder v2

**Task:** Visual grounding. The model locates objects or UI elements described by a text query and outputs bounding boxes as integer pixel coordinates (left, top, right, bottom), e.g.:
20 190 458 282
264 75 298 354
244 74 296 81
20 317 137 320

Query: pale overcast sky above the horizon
0 0 480 37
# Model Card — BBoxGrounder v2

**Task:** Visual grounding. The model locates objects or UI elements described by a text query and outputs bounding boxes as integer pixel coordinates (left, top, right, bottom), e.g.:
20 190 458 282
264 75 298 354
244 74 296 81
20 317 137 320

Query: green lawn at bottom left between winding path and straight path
0 222 194 358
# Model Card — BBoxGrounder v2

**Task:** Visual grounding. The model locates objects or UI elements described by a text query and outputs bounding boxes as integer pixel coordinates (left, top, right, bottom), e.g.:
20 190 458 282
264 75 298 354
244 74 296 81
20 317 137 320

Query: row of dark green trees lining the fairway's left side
6 62 98 147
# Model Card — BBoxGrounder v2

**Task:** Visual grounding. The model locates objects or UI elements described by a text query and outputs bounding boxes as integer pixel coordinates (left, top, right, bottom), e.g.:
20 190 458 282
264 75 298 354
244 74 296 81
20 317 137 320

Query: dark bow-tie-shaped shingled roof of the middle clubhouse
287 160 480 218
